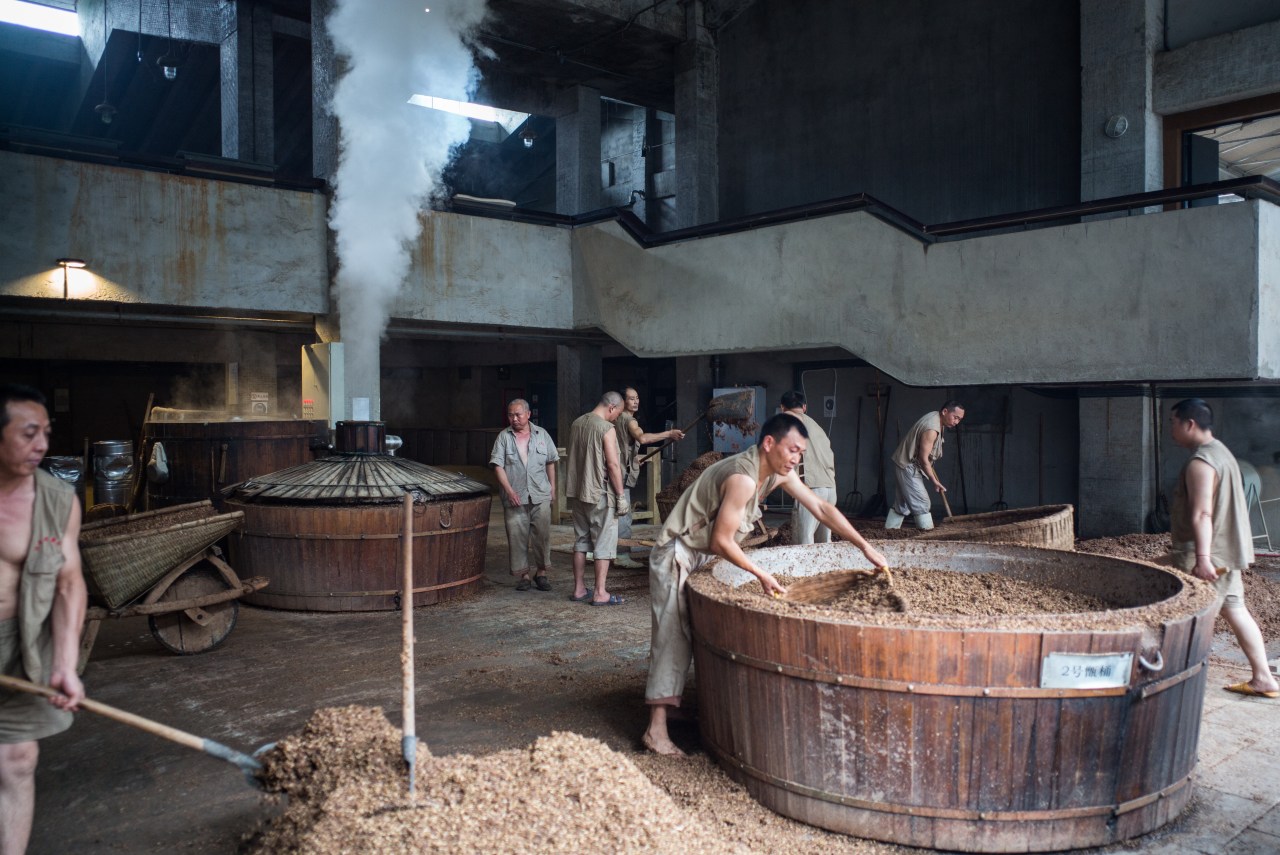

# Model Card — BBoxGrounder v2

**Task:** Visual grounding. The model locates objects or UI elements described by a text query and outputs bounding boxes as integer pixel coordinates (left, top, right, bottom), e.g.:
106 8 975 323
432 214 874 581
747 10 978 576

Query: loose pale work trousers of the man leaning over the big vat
644 538 716 707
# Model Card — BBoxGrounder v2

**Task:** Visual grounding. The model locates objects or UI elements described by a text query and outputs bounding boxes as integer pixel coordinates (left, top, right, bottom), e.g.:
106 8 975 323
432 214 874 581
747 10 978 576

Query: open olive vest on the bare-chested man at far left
18 468 76 683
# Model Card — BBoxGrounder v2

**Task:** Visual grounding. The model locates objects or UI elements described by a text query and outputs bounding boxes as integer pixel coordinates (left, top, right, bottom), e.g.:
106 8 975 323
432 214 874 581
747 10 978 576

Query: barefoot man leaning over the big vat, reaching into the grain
643 412 888 755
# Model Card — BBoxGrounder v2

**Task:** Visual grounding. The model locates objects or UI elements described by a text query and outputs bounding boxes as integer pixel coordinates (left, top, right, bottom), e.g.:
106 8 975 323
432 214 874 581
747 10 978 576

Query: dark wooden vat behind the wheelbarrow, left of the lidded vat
143 419 328 508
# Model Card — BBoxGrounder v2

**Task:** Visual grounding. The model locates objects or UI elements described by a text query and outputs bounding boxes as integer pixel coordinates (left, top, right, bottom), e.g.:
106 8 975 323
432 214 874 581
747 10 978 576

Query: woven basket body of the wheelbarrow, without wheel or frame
79 499 244 608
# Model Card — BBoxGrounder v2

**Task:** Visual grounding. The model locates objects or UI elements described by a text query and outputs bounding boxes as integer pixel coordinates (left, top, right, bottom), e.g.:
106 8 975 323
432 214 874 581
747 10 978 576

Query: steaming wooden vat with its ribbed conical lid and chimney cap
227 422 490 612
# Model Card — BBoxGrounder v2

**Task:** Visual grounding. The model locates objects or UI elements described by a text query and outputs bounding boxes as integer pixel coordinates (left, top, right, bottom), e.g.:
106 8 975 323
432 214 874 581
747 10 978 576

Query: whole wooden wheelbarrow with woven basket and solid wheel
77 499 268 672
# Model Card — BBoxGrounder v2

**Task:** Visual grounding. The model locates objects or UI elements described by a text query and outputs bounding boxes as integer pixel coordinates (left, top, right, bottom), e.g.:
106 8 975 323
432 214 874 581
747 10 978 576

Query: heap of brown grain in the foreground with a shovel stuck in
250 707 750 855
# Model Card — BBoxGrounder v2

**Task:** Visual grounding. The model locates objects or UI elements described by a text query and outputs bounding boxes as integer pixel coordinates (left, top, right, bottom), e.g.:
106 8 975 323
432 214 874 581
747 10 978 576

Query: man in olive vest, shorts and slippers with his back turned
564 392 631 605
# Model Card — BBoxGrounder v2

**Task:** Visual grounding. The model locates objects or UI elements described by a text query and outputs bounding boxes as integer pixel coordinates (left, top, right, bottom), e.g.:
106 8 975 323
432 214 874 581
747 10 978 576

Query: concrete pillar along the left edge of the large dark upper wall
676 0 719 228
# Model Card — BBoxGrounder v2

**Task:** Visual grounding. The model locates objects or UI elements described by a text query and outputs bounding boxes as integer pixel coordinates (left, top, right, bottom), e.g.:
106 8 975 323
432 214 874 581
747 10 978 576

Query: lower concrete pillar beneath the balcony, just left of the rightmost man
1076 394 1155 538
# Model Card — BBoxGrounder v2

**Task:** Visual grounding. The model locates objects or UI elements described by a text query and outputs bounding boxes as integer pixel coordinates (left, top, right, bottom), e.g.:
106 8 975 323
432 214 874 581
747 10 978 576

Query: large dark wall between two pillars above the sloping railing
718 0 1080 223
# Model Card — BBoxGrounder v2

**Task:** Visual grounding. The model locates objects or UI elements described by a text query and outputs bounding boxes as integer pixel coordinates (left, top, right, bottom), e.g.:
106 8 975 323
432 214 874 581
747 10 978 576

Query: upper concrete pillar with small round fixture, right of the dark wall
1080 0 1164 202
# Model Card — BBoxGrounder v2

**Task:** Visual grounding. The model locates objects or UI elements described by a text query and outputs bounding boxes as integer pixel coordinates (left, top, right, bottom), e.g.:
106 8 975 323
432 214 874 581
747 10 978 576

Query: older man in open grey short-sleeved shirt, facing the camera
489 398 559 591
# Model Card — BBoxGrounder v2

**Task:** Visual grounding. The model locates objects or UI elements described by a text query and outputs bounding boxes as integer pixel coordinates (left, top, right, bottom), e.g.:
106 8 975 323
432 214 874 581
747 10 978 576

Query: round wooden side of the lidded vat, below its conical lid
227 495 490 612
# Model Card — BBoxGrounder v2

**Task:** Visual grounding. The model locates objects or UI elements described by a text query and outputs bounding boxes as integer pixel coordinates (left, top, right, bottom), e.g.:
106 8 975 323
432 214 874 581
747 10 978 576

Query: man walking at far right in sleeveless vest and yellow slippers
1167 398 1280 698
